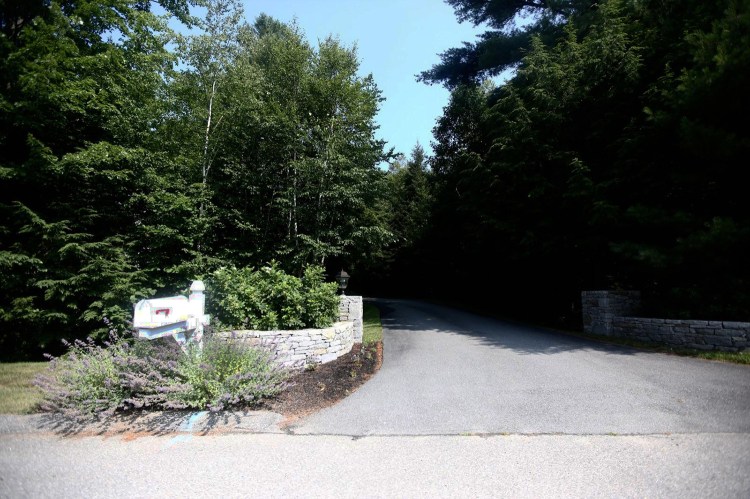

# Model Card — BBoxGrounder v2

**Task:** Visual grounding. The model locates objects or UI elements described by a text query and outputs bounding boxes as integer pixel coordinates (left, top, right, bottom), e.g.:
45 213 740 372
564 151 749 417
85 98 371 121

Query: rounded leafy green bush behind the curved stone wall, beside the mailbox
208 262 339 330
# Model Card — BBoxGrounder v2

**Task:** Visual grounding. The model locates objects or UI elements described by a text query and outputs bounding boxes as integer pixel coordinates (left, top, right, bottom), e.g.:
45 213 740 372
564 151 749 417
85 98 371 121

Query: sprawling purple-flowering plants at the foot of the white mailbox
35 333 289 415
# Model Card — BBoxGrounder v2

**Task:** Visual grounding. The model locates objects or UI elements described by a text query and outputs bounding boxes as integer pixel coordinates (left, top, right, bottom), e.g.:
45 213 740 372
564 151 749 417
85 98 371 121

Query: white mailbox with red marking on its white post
133 281 210 349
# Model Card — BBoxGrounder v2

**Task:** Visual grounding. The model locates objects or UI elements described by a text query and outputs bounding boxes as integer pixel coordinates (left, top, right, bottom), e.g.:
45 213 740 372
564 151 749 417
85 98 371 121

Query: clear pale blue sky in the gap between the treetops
238 0 483 156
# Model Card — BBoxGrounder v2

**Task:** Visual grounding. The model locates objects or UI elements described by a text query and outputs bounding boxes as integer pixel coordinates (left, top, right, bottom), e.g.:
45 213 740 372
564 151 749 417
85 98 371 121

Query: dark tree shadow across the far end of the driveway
374 299 645 355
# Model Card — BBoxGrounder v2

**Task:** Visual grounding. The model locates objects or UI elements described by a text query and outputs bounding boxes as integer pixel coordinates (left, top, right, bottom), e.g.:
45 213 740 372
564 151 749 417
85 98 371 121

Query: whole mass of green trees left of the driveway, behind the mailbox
0 0 390 360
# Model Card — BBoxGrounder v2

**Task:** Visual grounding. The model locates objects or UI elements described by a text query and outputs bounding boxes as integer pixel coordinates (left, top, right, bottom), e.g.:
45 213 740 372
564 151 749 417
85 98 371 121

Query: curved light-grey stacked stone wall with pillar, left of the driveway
217 296 362 369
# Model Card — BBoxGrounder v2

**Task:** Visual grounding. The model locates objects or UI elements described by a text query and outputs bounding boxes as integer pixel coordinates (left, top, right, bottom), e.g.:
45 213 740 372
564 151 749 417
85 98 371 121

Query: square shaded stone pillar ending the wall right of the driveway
581 291 641 336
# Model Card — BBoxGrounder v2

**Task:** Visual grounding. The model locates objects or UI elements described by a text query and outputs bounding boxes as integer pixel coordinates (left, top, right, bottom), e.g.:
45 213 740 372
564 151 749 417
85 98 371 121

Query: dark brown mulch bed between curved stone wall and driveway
263 342 383 426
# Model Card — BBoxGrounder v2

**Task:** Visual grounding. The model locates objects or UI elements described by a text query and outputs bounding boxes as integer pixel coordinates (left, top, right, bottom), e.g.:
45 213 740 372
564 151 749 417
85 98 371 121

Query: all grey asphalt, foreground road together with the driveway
0 301 750 498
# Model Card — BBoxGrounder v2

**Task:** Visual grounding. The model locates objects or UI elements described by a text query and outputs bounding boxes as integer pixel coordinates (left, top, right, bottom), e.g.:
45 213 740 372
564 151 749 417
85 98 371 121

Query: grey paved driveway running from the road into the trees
294 300 750 435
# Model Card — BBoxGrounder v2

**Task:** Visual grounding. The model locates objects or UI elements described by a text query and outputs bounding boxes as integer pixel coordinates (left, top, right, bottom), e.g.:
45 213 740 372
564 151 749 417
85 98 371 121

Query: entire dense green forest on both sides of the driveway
0 0 750 359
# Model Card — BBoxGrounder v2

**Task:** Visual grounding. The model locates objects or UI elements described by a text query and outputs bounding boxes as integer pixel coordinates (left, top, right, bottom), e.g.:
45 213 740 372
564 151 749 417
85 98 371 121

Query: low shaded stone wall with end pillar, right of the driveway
581 291 750 352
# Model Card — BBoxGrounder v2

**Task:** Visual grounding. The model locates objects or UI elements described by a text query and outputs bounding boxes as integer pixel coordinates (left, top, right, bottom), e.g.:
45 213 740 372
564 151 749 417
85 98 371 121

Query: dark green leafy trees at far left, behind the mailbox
0 0 203 359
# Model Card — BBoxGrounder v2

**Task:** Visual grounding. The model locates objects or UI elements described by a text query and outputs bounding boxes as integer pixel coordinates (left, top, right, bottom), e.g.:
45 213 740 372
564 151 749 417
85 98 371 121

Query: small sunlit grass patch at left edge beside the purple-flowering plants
0 362 49 414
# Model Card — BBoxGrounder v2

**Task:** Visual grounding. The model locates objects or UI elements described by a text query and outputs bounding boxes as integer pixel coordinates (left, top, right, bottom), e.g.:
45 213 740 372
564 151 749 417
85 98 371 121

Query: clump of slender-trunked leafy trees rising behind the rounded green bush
203 22 389 273
